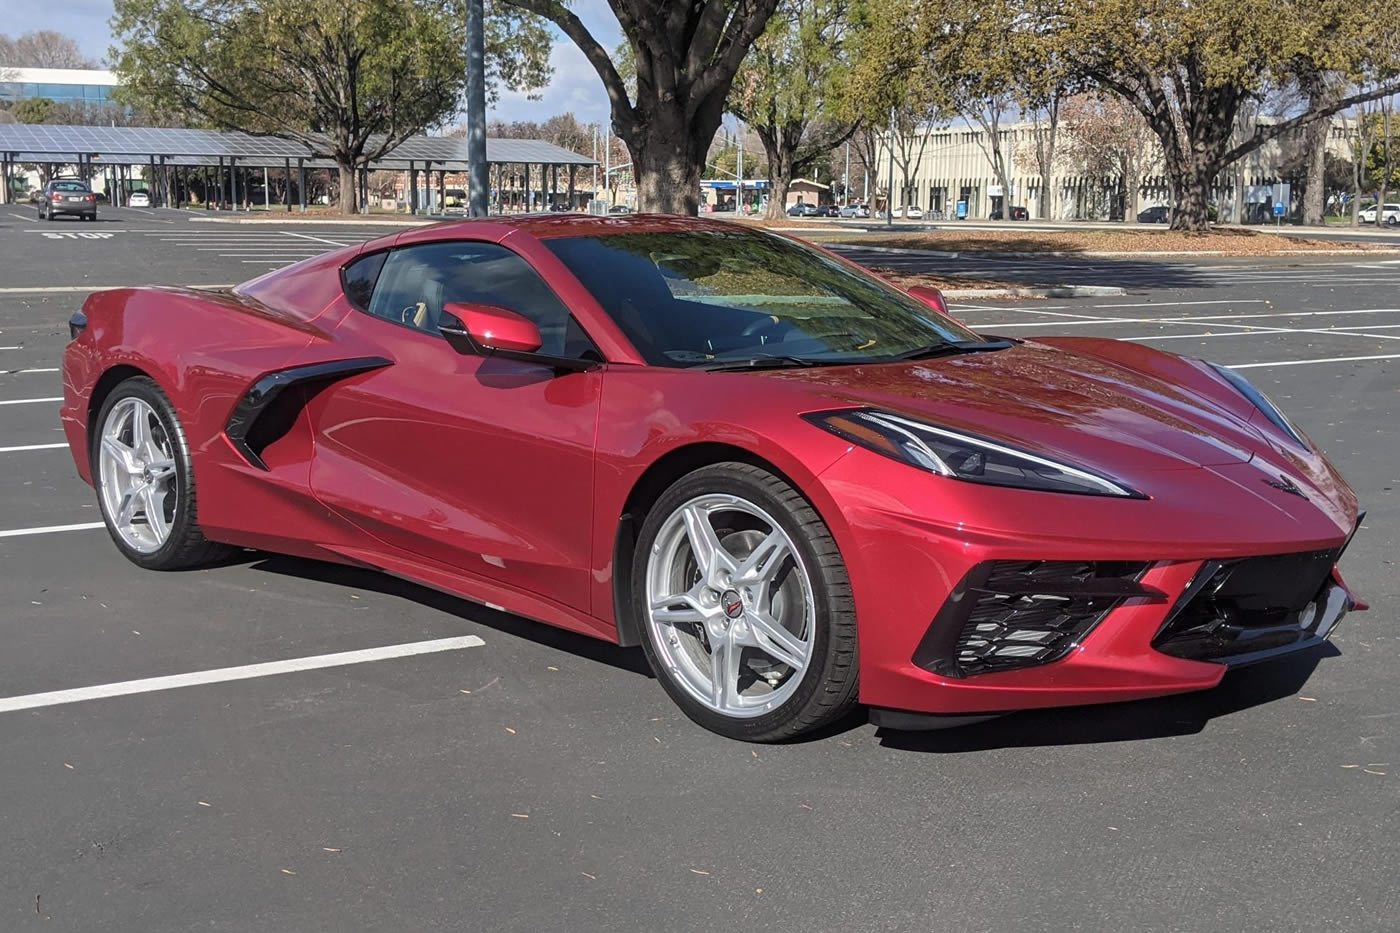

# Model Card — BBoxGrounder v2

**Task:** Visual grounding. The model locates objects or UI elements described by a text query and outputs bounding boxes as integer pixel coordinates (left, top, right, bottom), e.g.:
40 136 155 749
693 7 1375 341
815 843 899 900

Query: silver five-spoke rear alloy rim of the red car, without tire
98 398 178 553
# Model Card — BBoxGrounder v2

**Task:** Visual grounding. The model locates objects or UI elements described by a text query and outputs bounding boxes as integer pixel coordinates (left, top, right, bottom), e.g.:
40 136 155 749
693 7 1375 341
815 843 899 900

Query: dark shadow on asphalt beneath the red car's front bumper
876 642 1341 754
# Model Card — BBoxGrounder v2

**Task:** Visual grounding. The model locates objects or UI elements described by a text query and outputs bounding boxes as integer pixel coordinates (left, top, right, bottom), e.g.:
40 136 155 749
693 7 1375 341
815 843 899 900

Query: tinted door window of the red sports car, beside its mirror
364 241 592 357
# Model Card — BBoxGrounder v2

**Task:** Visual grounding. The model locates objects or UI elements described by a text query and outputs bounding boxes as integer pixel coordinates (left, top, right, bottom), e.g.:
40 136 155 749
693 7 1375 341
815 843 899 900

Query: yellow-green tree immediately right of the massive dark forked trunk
729 0 857 220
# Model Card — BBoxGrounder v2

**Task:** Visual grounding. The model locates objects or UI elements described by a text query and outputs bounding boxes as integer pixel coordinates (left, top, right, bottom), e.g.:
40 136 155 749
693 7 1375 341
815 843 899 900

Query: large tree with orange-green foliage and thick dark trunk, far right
1049 0 1400 231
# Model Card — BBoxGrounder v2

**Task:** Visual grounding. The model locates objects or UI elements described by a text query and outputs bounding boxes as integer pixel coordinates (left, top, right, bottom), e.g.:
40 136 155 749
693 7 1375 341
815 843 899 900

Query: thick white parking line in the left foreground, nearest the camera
0 635 486 713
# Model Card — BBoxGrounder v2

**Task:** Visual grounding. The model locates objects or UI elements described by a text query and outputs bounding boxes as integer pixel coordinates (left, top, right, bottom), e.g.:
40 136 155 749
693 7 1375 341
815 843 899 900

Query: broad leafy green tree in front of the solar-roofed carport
112 0 549 212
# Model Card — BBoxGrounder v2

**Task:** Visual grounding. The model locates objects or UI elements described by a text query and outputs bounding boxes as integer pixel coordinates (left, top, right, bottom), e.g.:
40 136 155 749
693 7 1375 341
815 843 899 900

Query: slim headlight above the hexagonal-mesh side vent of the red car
805 409 1147 499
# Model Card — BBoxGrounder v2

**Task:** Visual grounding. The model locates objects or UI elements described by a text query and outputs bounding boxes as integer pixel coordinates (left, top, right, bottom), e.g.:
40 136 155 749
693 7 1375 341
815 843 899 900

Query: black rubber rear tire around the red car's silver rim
88 375 228 570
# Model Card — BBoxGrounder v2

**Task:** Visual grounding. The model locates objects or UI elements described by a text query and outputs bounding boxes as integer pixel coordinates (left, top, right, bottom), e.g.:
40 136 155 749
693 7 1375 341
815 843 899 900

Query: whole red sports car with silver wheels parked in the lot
63 214 1364 741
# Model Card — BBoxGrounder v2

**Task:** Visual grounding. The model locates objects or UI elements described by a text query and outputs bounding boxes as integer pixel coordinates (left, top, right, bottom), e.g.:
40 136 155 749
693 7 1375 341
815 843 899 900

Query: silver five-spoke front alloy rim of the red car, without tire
647 495 816 719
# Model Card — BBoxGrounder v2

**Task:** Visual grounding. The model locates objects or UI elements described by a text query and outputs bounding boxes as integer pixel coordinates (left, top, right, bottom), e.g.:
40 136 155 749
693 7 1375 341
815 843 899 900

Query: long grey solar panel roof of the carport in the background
0 123 596 171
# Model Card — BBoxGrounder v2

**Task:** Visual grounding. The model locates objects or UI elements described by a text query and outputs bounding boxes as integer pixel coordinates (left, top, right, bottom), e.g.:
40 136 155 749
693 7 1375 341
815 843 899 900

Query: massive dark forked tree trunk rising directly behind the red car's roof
504 0 778 214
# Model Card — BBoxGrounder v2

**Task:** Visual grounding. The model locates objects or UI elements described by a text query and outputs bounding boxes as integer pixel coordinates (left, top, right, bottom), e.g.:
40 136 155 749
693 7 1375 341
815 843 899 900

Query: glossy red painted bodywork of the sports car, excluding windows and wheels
62 216 1361 713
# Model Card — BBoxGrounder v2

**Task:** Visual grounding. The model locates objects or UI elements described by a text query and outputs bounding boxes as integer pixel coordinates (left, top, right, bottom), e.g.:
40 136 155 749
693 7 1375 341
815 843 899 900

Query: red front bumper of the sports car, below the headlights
822 455 1364 716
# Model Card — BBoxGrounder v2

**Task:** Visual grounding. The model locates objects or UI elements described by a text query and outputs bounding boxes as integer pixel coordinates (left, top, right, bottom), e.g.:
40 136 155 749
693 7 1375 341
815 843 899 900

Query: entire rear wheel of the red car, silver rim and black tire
91 377 224 570
